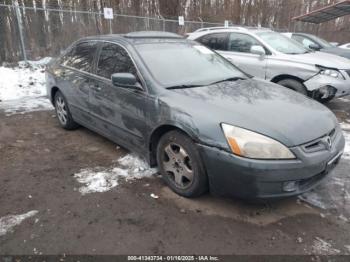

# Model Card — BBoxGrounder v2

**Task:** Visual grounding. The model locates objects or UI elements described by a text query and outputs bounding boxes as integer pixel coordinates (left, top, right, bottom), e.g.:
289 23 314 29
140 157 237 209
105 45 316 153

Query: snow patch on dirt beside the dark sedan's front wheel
74 154 157 195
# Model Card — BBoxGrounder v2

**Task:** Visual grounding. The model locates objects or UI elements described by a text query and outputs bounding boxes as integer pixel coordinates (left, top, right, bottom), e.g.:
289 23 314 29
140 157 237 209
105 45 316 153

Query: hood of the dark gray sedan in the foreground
166 79 337 147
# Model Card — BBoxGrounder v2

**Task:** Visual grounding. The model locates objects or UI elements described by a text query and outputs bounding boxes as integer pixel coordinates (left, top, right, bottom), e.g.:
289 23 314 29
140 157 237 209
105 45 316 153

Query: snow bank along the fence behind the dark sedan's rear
0 57 53 115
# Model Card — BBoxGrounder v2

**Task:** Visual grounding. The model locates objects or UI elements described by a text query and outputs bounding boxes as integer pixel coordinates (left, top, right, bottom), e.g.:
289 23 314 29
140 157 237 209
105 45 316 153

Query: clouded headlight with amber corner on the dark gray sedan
221 124 295 159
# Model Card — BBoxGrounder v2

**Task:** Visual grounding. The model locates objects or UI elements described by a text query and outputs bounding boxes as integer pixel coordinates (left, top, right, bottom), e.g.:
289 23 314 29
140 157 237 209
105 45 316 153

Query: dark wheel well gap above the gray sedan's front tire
149 125 191 167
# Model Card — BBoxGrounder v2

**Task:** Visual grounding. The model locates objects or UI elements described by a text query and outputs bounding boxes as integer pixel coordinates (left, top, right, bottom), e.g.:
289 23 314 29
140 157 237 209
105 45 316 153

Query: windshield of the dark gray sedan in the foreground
136 42 248 88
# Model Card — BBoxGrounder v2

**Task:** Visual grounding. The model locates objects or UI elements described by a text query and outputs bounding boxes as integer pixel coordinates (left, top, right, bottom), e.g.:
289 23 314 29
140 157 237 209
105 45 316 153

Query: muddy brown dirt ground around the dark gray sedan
0 99 350 255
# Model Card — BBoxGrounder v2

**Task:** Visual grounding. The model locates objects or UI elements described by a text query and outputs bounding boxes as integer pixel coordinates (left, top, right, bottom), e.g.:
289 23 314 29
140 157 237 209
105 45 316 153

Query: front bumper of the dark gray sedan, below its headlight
198 127 345 199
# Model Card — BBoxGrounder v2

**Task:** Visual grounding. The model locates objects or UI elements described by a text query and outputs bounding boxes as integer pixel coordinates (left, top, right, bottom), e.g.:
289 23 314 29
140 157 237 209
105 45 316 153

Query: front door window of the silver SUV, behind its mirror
228 33 261 53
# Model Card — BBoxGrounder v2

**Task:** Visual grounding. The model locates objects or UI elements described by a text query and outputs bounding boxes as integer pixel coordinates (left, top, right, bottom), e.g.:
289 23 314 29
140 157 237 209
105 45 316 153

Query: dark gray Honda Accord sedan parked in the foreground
46 32 344 199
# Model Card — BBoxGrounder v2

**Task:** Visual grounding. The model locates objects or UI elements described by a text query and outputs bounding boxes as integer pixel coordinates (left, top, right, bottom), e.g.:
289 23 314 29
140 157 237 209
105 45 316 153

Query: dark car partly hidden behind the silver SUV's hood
284 33 350 59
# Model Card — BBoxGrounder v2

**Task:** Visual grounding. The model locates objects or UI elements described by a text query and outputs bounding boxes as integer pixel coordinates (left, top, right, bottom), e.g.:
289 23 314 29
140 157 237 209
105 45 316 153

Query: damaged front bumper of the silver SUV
304 70 350 99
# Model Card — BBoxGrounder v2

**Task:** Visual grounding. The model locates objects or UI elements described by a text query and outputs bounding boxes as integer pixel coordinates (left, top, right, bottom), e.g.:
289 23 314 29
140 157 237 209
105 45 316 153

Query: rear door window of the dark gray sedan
63 42 97 72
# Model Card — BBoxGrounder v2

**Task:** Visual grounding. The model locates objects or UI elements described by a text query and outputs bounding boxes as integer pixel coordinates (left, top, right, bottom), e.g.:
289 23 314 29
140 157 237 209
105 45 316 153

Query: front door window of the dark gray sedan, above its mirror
97 43 136 79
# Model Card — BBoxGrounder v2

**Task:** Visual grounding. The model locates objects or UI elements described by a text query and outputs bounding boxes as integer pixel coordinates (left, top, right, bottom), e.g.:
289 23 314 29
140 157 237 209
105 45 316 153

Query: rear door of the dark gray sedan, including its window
58 41 97 122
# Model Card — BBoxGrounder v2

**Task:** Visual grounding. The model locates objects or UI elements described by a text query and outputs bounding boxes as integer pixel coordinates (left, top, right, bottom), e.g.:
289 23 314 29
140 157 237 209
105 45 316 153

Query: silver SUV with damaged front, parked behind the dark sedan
188 27 350 102
